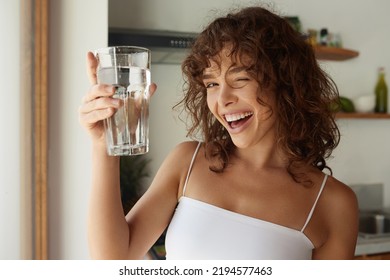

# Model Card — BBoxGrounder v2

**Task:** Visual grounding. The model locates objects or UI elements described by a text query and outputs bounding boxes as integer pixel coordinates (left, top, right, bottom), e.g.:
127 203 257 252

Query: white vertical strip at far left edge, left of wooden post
0 0 22 259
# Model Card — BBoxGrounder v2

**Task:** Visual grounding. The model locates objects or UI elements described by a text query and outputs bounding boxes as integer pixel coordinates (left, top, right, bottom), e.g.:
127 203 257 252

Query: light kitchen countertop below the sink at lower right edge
355 236 390 256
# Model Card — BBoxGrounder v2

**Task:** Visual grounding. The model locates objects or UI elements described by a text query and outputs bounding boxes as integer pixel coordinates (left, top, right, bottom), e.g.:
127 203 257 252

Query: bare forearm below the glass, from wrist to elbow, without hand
88 143 129 259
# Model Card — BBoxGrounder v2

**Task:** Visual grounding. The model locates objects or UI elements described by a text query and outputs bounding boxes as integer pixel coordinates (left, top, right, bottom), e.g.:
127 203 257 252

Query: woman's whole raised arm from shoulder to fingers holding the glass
79 53 189 259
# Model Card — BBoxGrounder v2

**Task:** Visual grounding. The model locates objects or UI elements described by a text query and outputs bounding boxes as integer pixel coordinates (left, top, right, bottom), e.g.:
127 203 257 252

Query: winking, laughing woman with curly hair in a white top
79 7 358 259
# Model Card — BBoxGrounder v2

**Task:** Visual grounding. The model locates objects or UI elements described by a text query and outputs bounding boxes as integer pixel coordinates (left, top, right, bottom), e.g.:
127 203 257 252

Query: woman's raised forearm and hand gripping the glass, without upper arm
79 53 156 259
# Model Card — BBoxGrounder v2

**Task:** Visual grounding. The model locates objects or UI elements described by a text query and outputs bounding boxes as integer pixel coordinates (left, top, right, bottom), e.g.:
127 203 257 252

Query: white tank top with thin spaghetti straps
165 144 327 260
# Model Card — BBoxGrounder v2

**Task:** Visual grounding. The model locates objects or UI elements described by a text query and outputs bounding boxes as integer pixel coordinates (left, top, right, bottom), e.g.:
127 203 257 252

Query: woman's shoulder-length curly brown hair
177 7 340 184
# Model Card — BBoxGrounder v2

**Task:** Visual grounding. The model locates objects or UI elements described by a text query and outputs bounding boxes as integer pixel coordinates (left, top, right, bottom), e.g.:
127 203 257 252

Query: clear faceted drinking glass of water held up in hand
95 46 151 156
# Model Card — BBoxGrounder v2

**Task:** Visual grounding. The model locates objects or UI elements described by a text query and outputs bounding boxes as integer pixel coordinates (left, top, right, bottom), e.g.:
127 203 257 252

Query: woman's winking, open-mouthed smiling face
203 49 276 151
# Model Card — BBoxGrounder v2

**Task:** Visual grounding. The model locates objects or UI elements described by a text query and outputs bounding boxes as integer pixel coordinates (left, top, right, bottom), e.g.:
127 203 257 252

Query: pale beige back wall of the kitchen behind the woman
109 0 390 206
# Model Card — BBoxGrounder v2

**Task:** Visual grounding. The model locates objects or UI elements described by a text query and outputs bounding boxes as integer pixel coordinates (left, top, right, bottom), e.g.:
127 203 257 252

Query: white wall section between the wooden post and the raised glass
48 0 108 259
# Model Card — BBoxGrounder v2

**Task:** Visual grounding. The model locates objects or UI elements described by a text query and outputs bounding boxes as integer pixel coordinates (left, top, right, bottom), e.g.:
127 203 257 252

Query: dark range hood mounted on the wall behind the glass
108 28 197 64
